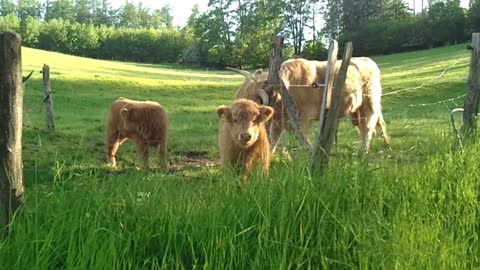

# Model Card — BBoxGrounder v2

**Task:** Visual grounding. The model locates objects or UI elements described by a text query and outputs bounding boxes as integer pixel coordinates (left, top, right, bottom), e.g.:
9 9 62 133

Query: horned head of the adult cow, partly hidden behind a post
227 67 270 105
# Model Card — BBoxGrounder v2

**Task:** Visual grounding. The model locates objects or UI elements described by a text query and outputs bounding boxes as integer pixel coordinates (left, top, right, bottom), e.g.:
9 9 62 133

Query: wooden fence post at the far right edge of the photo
462 33 480 137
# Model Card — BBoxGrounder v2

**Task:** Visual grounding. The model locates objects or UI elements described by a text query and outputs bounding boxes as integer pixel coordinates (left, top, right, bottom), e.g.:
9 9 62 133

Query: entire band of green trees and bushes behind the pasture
0 0 480 68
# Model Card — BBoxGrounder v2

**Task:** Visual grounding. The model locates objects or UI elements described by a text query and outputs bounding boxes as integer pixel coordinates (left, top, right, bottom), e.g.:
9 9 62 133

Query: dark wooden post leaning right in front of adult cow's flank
310 42 353 173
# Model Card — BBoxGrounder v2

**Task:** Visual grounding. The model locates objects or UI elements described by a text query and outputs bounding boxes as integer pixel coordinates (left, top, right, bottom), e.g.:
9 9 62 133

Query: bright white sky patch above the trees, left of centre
111 0 208 26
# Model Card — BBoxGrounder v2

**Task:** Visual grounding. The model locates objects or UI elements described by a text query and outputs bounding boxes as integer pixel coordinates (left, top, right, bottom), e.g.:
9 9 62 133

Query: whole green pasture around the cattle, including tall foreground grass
0 45 480 269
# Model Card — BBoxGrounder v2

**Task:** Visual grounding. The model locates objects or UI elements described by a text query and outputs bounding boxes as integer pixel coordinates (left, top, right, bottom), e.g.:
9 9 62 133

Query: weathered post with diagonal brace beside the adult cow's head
265 36 310 149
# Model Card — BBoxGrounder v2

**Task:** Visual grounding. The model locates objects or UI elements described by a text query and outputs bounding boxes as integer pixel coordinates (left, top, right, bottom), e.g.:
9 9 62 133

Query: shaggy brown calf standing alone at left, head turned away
105 97 168 170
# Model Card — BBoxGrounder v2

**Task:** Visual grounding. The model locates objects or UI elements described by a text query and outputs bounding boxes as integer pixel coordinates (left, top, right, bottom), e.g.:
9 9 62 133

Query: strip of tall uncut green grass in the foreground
0 136 480 269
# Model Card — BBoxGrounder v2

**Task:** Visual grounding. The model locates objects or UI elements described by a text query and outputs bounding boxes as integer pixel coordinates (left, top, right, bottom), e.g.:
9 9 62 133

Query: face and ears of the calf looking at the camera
217 99 273 148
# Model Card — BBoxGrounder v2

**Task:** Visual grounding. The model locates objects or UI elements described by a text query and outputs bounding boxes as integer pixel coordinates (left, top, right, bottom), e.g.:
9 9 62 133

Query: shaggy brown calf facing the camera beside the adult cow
217 99 273 178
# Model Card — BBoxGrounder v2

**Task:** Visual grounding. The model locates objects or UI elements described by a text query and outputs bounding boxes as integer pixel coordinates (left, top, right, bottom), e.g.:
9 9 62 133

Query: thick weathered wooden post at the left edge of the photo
0 33 24 237
